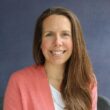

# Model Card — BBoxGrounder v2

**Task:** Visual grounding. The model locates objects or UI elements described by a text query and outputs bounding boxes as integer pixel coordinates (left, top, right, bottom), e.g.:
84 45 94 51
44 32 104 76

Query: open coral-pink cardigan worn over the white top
3 65 97 110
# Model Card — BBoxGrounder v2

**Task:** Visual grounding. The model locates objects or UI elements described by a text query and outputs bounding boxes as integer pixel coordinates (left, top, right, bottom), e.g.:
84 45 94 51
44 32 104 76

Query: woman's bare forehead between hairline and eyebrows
43 14 71 30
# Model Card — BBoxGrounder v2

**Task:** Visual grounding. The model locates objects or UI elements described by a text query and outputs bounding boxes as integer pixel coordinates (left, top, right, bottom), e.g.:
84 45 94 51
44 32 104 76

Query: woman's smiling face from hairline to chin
41 15 73 65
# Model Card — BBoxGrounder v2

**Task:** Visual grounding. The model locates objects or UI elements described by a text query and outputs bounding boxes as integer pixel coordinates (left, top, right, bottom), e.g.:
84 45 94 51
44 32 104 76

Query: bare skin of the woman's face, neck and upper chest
41 15 73 90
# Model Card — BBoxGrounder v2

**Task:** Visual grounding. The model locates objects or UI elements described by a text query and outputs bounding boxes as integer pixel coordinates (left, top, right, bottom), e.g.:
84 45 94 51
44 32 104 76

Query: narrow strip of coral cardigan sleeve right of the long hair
92 82 98 110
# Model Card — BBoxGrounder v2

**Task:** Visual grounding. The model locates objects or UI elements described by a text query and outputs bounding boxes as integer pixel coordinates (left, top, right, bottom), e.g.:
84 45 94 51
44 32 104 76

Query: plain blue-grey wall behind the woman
0 0 110 98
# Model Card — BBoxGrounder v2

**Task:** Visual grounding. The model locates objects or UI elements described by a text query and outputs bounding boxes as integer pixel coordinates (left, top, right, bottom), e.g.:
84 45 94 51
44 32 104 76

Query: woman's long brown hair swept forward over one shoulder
33 7 95 110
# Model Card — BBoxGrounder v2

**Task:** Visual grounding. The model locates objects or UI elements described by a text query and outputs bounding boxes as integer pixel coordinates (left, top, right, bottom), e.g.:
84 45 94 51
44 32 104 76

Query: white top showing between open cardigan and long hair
50 84 65 110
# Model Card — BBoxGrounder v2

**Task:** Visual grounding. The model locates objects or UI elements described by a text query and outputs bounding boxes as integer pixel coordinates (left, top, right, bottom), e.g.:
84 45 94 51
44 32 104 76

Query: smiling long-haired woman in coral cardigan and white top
4 7 97 110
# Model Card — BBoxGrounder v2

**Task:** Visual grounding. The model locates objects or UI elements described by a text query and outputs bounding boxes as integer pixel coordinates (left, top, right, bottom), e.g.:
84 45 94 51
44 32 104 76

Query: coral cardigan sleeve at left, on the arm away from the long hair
3 75 23 110
